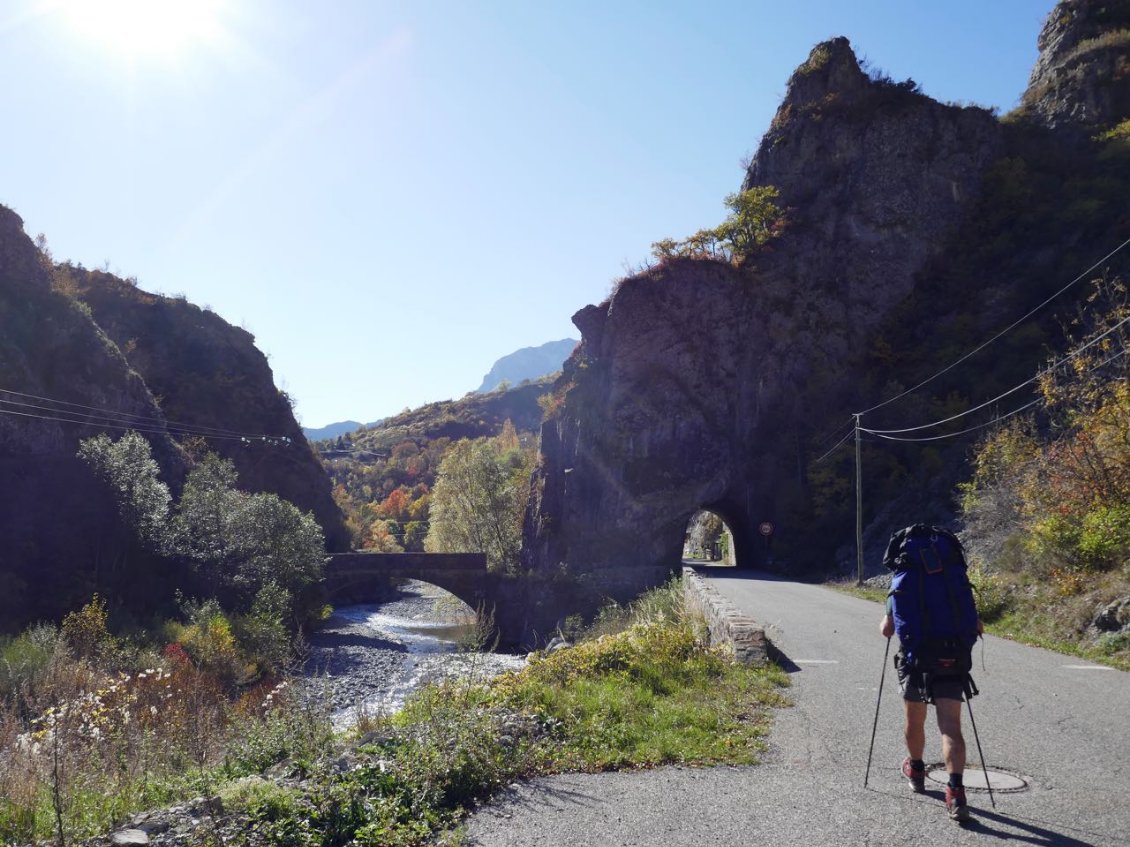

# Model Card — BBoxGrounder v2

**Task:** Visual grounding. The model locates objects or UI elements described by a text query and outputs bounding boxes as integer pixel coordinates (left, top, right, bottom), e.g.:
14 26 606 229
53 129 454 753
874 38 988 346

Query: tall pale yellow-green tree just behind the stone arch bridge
424 421 534 573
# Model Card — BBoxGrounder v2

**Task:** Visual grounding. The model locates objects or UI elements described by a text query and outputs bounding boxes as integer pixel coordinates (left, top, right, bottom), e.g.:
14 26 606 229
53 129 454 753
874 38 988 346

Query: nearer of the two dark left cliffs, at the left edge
0 207 184 630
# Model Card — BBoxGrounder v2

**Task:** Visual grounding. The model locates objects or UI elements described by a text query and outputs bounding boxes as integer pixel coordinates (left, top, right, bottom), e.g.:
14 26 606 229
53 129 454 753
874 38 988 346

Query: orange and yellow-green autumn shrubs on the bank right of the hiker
962 282 1130 667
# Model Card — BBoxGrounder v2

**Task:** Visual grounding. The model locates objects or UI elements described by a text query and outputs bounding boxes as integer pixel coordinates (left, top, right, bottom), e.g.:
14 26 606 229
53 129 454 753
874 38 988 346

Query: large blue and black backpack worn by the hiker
883 524 977 683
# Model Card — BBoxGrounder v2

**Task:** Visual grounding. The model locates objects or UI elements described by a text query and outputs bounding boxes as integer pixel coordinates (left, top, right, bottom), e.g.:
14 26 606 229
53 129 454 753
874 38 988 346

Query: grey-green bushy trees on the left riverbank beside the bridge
79 431 325 682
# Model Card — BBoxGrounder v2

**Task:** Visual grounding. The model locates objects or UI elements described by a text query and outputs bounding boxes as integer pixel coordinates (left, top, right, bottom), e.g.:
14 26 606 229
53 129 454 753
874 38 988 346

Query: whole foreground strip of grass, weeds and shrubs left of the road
0 584 786 847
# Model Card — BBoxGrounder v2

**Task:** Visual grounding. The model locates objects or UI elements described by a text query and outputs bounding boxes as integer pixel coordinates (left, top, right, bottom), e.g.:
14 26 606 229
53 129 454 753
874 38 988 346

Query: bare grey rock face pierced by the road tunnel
525 38 1001 596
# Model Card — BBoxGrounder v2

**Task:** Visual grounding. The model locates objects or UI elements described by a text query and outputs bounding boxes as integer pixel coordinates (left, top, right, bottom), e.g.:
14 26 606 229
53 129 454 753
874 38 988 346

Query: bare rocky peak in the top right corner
1023 0 1130 131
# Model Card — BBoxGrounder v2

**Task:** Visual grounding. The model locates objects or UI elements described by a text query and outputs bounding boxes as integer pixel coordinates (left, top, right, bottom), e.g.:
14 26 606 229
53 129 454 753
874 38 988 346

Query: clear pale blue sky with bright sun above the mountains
0 0 1053 427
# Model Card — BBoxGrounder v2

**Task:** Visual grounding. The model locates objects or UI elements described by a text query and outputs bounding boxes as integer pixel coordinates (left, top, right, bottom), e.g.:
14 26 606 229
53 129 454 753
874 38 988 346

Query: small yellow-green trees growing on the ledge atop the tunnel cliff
651 185 785 264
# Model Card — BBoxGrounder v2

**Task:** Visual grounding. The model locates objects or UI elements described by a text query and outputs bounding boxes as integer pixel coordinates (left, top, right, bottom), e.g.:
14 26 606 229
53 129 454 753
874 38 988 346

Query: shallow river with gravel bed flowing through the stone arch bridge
305 580 525 730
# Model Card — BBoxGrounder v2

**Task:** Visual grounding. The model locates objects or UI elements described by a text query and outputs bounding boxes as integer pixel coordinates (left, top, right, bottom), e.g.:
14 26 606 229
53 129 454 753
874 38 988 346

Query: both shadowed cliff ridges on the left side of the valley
0 207 346 631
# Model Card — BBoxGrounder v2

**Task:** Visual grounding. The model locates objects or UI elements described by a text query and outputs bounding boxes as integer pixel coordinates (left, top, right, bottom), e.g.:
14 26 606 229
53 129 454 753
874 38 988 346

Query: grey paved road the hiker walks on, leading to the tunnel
467 569 1130 847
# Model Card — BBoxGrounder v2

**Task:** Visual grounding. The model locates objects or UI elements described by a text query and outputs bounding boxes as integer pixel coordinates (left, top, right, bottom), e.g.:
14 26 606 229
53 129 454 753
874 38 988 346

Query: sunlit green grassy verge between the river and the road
253 590 788 846
